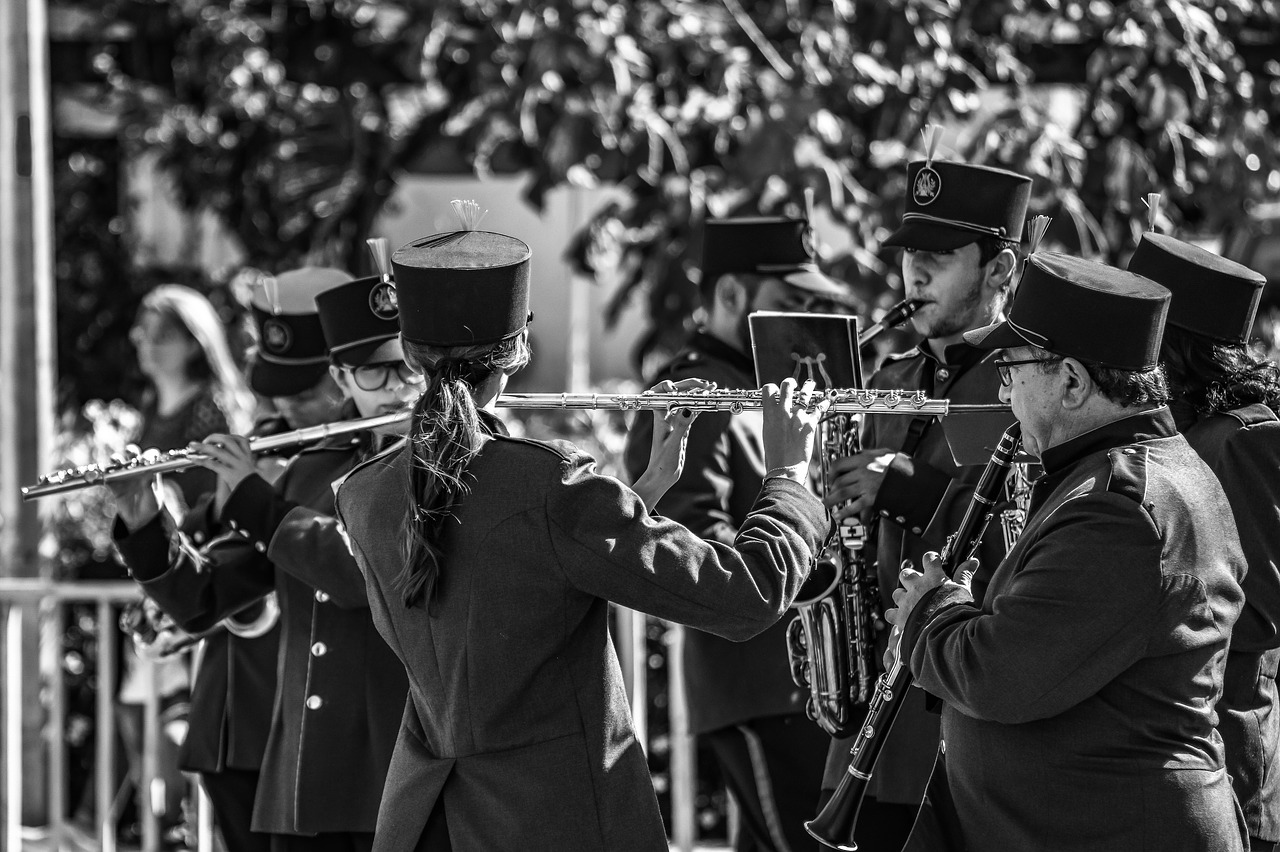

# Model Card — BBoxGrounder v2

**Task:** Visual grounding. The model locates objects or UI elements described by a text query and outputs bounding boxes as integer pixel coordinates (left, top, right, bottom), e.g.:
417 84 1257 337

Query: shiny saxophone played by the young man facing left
787 301 919 737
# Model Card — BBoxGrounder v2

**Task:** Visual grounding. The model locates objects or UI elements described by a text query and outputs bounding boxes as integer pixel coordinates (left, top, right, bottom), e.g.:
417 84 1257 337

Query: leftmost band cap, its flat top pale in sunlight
248 266 351 397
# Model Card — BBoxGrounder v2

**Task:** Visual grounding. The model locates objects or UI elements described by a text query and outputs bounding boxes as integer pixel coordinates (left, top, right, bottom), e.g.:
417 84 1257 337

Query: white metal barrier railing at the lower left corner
0 578 212 852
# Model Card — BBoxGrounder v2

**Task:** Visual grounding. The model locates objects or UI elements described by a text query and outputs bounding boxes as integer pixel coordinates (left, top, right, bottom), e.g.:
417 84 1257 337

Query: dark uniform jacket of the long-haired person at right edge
1183 403 1280 843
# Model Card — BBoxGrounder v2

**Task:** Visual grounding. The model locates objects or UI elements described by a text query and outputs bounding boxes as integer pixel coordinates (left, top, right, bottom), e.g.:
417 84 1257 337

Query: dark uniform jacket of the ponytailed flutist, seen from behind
338 421 826 852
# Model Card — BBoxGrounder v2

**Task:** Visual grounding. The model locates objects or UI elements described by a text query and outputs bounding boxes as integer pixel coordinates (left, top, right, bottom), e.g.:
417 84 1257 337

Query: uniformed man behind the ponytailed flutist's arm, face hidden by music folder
626 217 849 852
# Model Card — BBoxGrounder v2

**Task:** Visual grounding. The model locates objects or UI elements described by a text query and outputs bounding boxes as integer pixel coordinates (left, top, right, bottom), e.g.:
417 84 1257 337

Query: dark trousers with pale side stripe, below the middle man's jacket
701 714 831 852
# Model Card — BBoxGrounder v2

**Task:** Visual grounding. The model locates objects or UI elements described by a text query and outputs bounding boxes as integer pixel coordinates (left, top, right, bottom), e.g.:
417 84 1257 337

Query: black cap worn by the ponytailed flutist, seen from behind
392 230 534 347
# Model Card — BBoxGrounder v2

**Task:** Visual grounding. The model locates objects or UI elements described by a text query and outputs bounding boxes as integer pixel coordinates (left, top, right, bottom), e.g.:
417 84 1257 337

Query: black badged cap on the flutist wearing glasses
316 275 399 367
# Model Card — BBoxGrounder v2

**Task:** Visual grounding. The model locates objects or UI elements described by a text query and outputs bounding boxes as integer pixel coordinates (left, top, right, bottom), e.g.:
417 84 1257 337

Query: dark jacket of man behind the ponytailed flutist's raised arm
626 331 808 734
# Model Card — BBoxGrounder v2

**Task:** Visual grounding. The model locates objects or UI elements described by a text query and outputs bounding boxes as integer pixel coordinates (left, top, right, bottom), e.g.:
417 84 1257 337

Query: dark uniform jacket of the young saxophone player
823 343 1005 805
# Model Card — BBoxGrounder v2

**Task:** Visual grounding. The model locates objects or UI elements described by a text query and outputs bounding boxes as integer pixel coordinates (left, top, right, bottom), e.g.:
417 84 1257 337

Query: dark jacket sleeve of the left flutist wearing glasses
223 472 369 609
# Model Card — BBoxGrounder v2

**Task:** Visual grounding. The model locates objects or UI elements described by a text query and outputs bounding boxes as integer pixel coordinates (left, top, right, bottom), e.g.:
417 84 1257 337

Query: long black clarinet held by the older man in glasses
805 422 1021 852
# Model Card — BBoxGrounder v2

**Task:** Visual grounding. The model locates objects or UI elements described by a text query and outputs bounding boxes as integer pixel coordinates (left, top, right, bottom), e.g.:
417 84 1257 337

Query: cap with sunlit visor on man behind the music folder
703 216 850 299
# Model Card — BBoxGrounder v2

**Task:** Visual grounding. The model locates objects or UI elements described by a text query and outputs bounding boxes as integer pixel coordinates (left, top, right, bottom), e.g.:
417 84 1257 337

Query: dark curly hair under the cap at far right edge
1161 325 1280 417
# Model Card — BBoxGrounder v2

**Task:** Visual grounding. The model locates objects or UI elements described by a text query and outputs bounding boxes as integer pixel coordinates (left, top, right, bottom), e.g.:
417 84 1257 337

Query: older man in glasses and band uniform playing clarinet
888 252 1245 852
